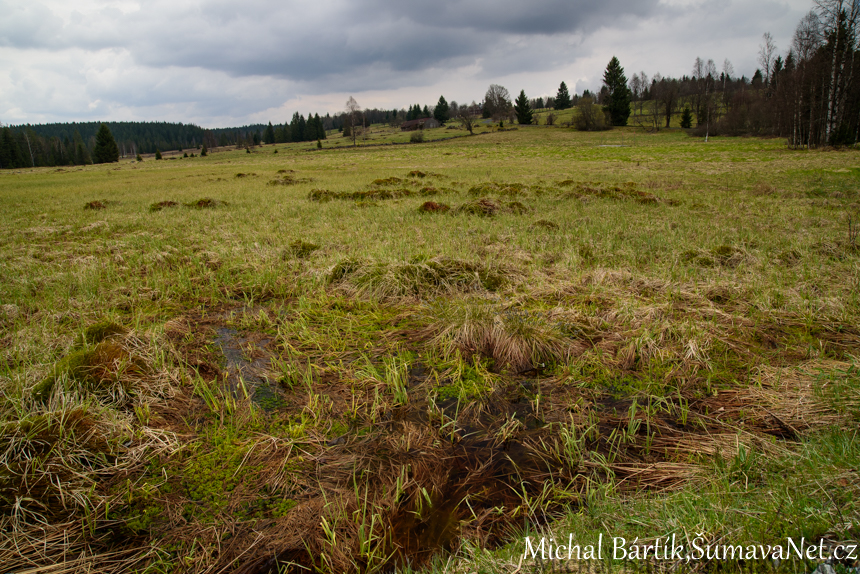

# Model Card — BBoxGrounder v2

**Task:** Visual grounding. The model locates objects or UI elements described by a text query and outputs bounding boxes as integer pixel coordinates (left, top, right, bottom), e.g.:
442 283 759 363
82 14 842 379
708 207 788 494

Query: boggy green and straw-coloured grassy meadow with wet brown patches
0 127 860 573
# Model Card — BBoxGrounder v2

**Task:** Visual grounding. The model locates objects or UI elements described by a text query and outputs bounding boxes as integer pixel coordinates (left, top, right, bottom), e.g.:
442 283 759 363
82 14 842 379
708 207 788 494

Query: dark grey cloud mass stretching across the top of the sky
0 0 659 85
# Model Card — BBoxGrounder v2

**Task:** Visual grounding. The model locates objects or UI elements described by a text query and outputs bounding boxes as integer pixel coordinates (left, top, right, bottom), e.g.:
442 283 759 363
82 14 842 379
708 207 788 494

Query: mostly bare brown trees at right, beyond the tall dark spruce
630 0 860 148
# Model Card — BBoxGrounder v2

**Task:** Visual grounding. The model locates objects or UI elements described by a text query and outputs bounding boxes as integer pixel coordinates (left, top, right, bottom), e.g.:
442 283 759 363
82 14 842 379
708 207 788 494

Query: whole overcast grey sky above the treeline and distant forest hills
0 0 812 128
